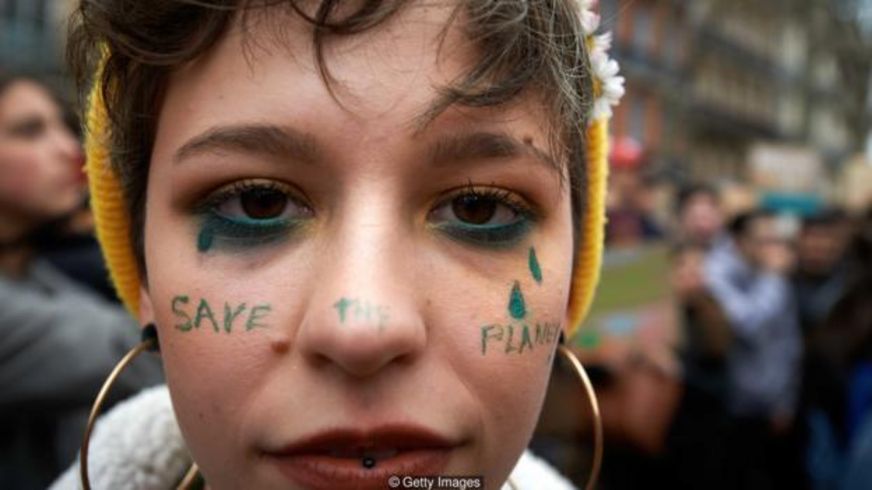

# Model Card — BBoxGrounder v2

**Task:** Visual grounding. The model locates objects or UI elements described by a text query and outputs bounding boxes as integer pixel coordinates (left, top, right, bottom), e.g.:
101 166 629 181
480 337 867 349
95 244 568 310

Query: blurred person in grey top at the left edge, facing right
0 76 161 490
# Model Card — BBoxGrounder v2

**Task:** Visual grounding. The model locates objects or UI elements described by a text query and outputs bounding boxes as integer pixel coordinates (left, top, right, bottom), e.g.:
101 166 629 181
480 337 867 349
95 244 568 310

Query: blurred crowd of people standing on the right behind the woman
579 138 872 490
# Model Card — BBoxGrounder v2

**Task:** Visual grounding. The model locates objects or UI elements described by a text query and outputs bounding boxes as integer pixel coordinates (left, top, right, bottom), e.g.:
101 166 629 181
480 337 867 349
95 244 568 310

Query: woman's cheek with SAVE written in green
145 212 305 474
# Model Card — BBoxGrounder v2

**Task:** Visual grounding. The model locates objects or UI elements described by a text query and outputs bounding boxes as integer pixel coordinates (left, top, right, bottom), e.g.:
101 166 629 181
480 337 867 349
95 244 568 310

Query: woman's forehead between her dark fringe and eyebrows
156 2 548 165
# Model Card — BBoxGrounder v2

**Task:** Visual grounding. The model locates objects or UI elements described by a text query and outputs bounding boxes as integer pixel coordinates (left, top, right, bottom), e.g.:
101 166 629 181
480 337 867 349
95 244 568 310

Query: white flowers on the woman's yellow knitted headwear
576 0 624 120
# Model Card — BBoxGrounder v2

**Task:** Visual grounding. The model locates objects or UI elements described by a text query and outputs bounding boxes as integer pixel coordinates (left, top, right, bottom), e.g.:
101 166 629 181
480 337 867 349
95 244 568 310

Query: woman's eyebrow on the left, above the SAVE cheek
173 124 321 163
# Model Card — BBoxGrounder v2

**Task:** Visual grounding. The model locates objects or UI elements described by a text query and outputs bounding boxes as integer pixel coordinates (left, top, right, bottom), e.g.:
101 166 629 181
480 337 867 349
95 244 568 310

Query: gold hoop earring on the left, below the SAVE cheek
79 323 199 490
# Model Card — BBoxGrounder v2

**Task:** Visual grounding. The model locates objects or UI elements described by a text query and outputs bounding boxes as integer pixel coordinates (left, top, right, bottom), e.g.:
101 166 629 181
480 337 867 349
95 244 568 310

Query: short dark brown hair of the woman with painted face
67 0 593 276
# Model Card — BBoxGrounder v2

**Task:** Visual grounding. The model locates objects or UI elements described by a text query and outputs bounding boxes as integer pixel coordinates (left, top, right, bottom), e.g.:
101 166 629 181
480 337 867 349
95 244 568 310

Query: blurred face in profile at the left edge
0 80 83 223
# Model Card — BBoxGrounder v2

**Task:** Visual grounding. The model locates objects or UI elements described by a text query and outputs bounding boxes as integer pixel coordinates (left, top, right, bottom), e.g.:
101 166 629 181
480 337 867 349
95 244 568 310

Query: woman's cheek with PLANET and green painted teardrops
429 239 572 472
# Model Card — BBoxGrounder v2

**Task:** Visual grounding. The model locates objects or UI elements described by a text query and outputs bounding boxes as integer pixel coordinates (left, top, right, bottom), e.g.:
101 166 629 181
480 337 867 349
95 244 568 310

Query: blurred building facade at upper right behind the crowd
600 0 872 186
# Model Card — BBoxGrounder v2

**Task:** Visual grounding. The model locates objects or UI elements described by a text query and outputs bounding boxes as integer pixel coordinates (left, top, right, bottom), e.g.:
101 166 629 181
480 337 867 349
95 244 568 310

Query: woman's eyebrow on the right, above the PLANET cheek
430 131 561 172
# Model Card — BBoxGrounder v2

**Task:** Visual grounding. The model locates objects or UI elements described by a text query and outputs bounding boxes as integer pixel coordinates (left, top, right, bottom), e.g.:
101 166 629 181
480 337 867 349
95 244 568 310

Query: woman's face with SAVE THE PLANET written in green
142 7 573 489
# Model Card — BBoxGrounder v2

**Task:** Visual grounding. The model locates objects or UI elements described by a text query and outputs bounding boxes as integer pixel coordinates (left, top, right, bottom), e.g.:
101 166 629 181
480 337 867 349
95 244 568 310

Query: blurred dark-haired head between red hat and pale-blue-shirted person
675 183 725 250
